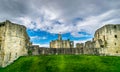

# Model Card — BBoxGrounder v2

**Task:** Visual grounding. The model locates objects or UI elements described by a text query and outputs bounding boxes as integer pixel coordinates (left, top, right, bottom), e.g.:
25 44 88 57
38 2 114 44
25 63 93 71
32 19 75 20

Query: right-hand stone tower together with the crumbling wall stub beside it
83 24 120 56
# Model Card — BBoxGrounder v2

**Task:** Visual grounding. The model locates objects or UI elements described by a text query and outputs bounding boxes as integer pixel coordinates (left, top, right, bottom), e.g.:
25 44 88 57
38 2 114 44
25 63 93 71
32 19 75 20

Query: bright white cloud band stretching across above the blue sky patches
5 9 120 37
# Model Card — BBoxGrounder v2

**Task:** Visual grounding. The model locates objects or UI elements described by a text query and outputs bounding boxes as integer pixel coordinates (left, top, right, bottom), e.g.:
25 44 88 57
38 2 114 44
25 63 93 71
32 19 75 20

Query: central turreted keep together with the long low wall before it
28 34 83 55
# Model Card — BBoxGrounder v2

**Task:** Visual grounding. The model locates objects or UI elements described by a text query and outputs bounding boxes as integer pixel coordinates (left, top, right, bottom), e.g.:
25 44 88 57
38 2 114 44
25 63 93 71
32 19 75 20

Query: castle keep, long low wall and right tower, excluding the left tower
29 24 120 56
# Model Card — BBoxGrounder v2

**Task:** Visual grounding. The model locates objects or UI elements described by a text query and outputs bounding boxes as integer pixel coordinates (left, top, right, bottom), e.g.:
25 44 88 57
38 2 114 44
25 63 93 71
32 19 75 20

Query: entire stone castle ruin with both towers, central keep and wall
0 20 120 67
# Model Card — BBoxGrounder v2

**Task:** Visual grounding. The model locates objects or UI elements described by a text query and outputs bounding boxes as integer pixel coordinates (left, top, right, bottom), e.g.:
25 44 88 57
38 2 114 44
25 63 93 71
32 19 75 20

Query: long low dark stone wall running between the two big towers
28 46 83 55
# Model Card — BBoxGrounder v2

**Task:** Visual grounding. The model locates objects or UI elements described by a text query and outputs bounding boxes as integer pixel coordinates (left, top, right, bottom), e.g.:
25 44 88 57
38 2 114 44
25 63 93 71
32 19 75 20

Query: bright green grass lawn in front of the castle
0 55 120 72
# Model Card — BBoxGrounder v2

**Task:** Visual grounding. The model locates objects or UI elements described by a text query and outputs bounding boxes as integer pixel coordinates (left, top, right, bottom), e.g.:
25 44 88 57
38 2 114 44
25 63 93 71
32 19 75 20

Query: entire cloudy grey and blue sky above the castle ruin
0 0 120 47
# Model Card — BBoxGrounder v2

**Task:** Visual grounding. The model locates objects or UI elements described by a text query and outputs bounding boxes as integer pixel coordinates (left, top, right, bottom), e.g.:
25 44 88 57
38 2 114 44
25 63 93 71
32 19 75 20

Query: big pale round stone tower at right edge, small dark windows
94 24 120 55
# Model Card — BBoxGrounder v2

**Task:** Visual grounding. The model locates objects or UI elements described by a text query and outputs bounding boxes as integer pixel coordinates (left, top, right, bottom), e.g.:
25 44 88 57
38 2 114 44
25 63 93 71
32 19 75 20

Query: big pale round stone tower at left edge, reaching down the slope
0 20 30 67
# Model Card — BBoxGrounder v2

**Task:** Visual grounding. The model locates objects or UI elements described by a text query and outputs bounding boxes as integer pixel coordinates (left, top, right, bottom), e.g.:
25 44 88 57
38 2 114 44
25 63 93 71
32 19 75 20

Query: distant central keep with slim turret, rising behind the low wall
50 34 74 48
